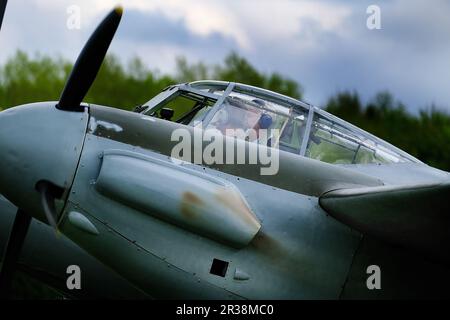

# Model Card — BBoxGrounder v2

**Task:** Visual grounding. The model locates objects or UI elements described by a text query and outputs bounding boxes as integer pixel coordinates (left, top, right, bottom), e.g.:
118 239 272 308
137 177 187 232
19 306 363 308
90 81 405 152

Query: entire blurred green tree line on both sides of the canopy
0 51 450 170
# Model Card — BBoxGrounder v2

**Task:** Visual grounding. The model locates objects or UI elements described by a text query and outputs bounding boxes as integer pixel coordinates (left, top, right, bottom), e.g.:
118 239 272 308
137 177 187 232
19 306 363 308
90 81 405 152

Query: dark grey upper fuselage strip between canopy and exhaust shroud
89 106 383 197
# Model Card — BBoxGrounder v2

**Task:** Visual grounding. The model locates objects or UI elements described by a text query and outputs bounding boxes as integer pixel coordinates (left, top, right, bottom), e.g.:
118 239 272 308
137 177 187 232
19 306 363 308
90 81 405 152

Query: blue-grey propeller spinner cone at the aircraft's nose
0 102 89 222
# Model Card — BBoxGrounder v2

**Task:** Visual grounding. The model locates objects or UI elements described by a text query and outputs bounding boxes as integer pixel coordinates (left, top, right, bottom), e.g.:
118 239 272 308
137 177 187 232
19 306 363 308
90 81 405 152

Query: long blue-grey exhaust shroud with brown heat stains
96 150 261 248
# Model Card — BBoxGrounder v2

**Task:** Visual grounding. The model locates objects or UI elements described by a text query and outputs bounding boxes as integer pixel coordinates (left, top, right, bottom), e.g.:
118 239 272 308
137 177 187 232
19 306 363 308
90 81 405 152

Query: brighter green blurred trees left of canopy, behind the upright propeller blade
0 51 301 110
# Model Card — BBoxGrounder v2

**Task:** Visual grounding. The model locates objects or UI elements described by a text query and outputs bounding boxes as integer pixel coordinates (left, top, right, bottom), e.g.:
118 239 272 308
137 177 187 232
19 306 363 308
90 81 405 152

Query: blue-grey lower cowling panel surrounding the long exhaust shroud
61 129 360 299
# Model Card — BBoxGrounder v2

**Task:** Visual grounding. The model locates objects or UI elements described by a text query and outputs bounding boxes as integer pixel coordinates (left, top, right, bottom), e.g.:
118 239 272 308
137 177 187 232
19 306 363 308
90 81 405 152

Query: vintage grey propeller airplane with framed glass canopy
0 2 450 300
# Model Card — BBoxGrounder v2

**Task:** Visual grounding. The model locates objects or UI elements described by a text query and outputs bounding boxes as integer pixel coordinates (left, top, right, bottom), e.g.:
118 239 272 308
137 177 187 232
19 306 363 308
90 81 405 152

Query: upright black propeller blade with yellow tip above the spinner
56 7 123 111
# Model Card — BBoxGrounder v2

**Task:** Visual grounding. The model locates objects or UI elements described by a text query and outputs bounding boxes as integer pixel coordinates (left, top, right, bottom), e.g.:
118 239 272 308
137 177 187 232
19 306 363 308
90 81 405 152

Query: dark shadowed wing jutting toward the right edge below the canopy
319 182 450 264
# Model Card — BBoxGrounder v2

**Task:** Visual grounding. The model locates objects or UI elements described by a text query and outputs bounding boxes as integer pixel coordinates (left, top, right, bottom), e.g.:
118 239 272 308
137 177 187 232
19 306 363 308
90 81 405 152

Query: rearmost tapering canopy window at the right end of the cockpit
306 114 410 164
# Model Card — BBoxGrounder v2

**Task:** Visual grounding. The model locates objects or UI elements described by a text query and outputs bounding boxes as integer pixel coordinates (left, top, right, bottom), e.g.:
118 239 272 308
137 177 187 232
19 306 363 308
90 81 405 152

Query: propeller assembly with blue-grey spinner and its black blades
0 1 132 298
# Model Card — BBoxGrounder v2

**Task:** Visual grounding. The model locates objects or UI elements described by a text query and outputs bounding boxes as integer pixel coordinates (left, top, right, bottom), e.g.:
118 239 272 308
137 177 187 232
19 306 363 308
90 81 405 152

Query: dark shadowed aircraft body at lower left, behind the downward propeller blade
0 195 150 299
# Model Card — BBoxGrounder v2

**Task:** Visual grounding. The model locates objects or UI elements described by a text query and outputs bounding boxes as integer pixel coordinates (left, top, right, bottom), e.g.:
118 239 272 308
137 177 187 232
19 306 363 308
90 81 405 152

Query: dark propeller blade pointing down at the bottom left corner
0 209 32 299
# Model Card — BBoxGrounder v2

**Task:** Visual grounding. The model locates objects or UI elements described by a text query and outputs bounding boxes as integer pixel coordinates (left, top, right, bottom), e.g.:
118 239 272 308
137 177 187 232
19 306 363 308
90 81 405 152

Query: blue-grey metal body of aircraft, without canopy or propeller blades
0 82 450 299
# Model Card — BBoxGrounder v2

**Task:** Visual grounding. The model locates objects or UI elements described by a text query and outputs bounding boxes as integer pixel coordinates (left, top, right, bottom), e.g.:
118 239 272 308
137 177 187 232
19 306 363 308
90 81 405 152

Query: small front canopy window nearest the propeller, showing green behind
144 91 216 126
